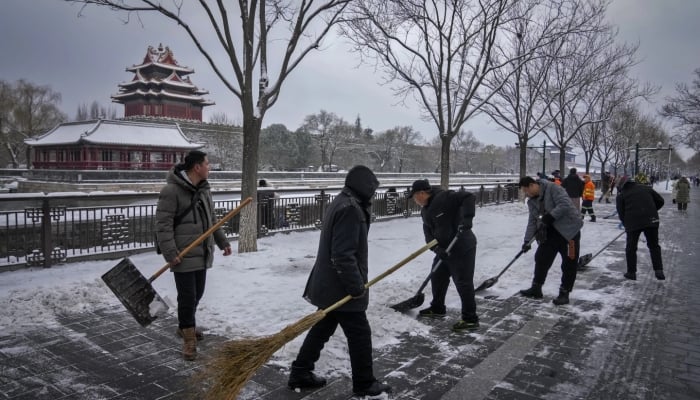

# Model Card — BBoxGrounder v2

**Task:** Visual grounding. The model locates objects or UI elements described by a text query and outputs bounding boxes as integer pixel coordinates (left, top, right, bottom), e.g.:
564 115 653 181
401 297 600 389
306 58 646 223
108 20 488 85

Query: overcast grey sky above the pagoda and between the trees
0 0 700 152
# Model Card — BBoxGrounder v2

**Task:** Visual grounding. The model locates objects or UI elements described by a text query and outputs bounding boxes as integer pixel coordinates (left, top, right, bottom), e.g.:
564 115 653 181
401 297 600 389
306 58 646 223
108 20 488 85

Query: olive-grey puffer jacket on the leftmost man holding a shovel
156 164 229 272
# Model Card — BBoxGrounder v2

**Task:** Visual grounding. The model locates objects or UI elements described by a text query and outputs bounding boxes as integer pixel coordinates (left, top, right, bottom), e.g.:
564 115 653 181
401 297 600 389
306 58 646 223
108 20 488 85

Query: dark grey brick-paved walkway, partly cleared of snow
0 189 700 400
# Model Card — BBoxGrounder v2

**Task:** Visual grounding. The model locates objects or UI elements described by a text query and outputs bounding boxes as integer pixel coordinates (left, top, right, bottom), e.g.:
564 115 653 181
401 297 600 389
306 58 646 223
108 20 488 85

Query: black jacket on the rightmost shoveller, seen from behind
615 181 664 232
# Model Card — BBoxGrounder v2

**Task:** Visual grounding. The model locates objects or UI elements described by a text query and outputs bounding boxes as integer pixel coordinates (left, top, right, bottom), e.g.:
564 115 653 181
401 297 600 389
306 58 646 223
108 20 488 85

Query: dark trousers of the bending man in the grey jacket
532 226 581 292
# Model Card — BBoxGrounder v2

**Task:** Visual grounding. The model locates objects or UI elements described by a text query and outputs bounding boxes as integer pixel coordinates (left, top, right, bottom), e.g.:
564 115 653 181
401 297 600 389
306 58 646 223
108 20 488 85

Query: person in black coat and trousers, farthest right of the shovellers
615 177 666 280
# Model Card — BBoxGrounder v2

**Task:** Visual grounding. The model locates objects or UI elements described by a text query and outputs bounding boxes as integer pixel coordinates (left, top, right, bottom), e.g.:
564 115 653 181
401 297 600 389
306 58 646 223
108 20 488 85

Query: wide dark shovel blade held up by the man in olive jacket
102 258 168 327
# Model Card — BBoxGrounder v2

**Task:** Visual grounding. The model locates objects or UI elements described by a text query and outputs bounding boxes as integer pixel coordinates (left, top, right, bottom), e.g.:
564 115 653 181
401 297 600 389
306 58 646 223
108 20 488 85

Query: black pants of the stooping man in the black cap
430 230 479 322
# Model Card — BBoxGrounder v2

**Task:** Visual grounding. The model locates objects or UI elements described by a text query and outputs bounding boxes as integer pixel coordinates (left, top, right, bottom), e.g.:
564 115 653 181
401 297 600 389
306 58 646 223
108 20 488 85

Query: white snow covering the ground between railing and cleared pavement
0 182 676 376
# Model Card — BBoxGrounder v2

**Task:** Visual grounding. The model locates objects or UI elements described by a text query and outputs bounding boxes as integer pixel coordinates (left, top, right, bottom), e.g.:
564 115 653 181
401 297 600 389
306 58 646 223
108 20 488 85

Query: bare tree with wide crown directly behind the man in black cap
341 0 552 187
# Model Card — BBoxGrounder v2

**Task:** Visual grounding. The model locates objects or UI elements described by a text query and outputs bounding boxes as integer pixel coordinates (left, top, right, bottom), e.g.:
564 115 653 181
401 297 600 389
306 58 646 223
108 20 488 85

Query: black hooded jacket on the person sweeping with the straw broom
304 166 379 311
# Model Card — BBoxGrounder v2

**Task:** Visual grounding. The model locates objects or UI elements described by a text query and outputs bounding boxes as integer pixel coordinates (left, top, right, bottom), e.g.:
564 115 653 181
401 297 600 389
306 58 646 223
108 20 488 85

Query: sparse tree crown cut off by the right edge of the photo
661 68 700 151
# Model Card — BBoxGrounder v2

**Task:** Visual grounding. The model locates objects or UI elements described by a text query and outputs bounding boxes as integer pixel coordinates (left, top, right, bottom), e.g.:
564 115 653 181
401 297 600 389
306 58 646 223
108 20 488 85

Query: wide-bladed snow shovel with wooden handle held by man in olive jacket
102 197 253 327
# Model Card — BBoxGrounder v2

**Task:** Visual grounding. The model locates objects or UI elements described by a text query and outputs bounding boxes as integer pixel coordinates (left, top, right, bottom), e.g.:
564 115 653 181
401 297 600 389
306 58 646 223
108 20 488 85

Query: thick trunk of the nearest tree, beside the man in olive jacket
238 112 262 253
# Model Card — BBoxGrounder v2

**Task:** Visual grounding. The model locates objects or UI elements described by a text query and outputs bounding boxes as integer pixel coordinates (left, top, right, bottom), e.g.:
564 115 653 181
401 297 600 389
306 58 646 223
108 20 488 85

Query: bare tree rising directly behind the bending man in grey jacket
482 0 607 176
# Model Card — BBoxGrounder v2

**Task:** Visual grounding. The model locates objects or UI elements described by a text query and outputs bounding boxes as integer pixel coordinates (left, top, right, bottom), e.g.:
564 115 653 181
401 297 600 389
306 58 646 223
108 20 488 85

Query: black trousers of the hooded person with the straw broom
292 311 376 390
